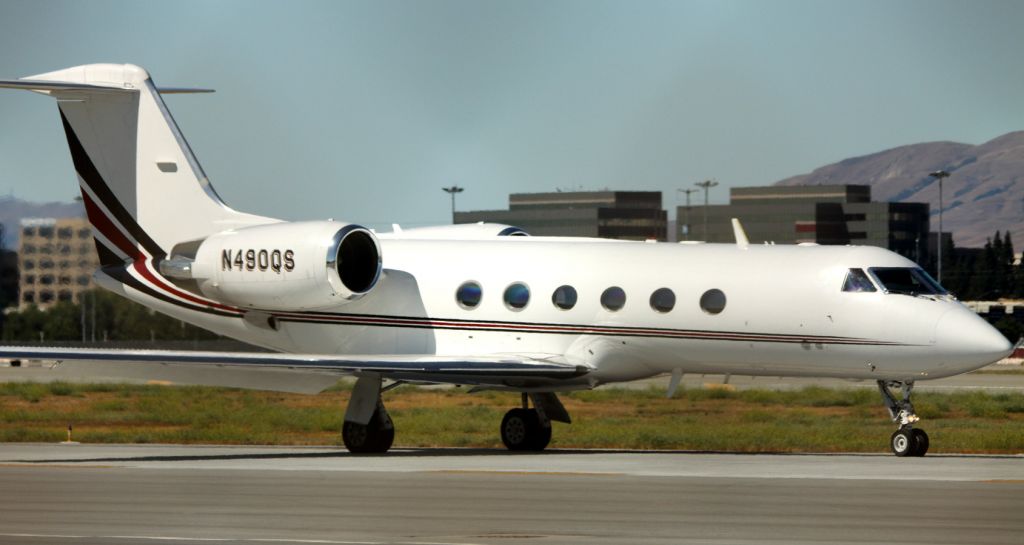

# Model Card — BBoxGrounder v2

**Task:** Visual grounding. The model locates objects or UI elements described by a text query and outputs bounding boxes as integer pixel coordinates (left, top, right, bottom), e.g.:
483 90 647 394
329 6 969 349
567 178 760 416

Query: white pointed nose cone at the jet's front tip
935 307 1014 371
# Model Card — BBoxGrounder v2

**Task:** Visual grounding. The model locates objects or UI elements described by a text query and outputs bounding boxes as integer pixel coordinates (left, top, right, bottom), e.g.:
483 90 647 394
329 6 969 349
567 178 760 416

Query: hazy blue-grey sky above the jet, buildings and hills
0 0 1024 229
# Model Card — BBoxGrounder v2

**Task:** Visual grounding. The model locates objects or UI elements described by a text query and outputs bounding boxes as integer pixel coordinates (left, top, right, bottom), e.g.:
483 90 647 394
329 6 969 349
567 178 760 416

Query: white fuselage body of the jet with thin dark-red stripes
99 235 1005 387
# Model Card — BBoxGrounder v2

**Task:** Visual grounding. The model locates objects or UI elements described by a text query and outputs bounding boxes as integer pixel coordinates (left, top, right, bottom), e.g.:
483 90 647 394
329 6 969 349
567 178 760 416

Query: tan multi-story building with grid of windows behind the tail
17 218 99 308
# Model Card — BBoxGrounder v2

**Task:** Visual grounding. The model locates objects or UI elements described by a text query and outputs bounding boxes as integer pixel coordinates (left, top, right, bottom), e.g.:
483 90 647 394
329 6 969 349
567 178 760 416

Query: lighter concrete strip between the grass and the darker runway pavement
0 444 1024 483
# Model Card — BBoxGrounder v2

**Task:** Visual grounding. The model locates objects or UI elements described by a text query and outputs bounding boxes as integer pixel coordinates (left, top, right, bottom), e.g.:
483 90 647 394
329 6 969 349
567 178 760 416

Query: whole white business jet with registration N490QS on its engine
0 65 1012 456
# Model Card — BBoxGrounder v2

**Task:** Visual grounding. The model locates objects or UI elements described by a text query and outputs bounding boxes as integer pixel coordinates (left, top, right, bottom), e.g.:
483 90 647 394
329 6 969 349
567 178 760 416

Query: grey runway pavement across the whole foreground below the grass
0 445 1024 545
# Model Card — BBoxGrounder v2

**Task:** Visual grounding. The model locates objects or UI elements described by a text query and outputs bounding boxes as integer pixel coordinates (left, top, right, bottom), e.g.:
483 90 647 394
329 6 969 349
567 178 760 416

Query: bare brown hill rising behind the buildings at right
776 131 1024 247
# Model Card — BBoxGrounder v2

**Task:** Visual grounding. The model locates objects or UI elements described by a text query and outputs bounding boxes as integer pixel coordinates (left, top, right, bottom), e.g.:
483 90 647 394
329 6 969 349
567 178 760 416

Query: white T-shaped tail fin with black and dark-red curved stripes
0 65 274 265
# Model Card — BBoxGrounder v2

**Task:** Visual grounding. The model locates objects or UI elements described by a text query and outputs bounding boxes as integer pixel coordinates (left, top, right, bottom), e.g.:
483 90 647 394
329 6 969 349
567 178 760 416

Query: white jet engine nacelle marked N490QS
176 221 381 310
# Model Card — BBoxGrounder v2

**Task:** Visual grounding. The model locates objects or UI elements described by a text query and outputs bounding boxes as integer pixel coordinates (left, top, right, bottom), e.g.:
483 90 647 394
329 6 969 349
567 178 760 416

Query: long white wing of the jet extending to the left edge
0 346 590 393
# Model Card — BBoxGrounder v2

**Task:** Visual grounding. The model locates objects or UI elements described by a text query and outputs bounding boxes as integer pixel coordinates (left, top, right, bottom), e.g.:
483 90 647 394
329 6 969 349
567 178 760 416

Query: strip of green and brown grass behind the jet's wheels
0 383 1024 454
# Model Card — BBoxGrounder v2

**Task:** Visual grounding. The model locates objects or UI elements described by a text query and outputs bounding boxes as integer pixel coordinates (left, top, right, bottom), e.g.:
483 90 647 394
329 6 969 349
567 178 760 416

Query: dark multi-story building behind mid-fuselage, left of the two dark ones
455 191 668 241
